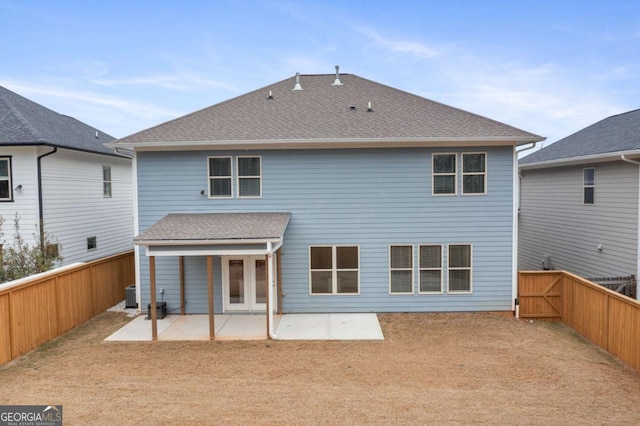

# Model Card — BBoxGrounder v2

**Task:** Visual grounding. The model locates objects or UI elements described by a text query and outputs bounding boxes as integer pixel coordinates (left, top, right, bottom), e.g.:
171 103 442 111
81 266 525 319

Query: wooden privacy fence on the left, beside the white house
0 251 135 364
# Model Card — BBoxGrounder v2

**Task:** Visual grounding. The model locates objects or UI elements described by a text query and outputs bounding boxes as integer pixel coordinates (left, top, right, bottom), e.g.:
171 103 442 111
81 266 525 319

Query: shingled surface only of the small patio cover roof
134 213 291 244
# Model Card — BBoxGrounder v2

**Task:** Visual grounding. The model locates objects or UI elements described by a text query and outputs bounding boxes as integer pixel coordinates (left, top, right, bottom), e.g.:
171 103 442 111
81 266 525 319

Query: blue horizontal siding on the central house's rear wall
137 147 513 313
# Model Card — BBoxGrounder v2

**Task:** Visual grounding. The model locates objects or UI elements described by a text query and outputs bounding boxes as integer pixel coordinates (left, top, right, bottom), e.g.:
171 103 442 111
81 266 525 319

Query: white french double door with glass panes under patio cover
222 256 267 312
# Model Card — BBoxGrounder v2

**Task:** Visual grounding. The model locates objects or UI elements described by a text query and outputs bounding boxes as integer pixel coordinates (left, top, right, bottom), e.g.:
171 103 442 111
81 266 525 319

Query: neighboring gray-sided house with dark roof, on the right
519 110 640 298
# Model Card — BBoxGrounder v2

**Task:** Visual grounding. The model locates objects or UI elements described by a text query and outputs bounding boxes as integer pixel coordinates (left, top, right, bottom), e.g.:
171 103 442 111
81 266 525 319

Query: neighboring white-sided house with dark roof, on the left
0 87 133 264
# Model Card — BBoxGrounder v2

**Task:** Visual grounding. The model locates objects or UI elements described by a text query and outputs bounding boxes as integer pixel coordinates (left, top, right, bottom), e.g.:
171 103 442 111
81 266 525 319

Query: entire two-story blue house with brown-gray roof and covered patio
110 67 544 338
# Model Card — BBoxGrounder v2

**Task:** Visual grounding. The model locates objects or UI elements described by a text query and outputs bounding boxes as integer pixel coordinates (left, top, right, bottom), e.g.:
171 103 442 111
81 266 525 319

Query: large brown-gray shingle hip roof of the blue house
115 74 543 147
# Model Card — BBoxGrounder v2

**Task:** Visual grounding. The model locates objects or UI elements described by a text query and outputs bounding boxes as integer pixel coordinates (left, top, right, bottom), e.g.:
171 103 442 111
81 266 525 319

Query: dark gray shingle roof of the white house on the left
0 86 115 155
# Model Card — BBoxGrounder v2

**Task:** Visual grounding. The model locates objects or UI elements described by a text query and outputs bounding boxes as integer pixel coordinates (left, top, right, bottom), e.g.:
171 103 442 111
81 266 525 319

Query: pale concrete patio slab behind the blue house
105 314 384 342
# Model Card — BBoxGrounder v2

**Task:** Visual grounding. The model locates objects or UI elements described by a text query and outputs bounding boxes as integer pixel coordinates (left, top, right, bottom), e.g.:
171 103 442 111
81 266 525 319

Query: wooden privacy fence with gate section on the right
518 271 640 370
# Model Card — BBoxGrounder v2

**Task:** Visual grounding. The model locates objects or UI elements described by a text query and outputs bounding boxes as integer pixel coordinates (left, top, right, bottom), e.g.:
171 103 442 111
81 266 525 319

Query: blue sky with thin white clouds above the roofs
0 0 640 145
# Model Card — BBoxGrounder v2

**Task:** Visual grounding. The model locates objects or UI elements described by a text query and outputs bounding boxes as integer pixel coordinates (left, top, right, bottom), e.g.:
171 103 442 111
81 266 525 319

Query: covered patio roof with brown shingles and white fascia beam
133 213 291 256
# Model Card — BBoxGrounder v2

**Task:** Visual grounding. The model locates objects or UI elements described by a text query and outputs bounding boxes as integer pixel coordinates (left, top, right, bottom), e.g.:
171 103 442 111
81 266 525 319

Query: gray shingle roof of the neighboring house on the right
520 109 640 165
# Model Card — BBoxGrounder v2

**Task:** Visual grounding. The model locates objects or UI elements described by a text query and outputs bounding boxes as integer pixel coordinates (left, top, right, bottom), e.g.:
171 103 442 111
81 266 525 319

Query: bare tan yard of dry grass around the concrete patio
0 312 640 425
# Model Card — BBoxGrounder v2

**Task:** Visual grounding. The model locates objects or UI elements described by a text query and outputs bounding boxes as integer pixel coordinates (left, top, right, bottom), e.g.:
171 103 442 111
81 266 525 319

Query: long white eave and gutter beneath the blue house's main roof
105 135 546 151
